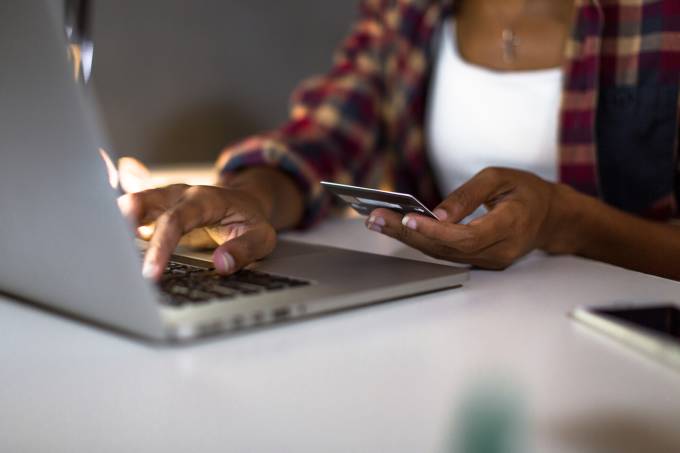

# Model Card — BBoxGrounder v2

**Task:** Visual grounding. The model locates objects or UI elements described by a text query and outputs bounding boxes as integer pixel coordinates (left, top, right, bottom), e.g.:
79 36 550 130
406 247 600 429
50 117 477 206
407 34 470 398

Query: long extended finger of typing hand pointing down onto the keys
143 187 229 280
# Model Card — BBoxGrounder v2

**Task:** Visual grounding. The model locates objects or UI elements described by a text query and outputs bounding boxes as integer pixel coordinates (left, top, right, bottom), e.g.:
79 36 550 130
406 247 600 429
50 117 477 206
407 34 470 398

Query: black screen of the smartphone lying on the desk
592 304 680 343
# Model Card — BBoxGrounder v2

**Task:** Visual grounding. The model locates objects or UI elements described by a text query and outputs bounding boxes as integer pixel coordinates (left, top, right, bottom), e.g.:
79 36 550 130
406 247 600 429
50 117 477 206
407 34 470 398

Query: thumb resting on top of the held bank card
434 168 512 223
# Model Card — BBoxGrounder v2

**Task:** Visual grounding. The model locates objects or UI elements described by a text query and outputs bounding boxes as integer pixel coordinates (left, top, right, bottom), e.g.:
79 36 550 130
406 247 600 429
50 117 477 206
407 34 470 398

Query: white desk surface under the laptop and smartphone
0 221 680 453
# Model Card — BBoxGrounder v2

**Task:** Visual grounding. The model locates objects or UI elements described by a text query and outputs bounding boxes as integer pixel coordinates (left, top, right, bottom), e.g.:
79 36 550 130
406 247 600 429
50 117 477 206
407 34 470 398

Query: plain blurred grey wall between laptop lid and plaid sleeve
92 0 357 163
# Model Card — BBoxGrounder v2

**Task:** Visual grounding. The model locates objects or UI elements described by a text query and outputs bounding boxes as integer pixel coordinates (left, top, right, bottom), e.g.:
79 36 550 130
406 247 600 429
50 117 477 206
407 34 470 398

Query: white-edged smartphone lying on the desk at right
571 303 680 371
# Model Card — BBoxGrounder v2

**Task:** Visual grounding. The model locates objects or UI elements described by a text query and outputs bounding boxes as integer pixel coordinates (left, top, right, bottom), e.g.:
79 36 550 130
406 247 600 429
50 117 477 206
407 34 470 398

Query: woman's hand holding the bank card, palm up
366 168 571 269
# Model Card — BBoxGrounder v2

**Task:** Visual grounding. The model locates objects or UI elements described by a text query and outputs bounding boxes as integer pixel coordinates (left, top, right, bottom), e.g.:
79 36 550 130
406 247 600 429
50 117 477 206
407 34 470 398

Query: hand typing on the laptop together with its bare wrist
118 167 304 280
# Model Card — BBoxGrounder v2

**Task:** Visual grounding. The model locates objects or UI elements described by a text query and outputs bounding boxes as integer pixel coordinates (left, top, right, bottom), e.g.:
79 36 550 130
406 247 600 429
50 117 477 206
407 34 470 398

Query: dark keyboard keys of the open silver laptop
159 262 310 306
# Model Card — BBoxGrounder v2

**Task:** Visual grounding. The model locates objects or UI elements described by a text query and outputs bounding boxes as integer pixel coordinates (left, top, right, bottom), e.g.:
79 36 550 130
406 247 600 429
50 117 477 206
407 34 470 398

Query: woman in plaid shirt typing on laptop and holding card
120 0 680 279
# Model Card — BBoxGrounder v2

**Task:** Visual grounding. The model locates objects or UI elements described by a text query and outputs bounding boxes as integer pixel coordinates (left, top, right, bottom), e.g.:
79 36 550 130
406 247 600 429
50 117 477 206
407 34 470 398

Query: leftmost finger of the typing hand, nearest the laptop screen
118 184 189 226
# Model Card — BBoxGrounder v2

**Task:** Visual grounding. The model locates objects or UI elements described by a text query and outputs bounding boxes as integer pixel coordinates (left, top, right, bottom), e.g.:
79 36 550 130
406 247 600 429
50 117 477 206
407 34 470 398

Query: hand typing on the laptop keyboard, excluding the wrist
118 184 276 280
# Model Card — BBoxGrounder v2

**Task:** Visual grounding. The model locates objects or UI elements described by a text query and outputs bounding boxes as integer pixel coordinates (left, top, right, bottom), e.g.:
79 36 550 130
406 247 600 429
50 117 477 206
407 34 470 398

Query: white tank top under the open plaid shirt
426 21 562 196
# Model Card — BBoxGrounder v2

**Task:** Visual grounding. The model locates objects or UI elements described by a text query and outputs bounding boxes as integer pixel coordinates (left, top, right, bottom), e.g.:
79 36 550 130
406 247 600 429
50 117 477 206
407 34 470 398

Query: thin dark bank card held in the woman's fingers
321 181 439 220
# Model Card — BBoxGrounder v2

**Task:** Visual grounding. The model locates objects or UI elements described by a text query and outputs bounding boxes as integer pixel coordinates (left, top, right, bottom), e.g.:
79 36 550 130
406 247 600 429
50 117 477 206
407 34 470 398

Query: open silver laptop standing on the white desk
0 0 468 342
